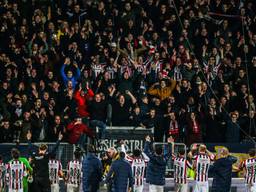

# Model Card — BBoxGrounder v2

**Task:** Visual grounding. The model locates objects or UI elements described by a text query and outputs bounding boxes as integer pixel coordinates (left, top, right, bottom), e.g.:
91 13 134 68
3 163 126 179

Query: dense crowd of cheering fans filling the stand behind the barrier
0 0 256 144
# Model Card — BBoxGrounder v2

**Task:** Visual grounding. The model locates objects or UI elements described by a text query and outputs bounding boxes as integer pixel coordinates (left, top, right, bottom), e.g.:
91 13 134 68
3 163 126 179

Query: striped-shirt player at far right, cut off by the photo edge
240 149 256 192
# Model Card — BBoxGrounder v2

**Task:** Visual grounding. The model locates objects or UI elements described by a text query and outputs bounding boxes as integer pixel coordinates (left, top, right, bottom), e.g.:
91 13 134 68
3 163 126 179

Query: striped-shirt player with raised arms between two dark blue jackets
121 142 149 192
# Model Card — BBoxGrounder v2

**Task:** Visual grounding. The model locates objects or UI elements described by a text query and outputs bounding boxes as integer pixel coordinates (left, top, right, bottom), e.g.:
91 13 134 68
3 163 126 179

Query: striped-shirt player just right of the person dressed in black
48 154 63 192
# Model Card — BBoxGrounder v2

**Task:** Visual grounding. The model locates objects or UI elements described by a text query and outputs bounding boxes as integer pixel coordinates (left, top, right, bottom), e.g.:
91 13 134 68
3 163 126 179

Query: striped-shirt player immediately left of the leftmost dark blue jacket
66 148 82 192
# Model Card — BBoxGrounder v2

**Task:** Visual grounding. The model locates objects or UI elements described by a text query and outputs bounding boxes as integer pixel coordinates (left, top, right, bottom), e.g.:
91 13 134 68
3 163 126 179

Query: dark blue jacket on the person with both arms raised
144 142 171 185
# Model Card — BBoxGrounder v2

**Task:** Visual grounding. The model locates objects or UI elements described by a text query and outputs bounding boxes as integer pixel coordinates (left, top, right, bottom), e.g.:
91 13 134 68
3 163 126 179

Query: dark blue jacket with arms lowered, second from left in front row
106 159 134 192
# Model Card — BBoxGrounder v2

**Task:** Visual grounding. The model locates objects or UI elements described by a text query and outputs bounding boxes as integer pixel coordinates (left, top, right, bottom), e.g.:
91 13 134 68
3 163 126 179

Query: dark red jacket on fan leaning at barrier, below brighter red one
67 121 94 144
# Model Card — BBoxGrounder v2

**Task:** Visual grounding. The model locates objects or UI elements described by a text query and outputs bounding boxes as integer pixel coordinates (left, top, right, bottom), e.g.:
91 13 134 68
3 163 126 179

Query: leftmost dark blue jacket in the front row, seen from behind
82 153 102 192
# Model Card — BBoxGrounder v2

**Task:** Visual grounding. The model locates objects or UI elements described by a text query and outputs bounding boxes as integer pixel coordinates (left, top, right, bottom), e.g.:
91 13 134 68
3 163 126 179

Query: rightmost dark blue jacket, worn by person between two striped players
210 156 237 192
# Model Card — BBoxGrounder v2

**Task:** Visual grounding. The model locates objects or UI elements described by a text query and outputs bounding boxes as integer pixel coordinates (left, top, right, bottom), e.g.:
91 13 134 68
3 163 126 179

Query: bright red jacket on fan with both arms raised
74 89 94 117
